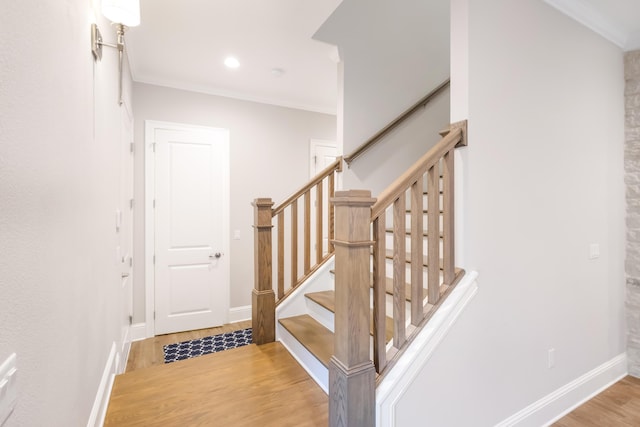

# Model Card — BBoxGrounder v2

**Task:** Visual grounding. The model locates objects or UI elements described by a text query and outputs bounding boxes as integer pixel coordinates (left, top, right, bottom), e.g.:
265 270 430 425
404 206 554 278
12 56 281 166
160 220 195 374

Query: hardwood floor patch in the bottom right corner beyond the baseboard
553 376 640 427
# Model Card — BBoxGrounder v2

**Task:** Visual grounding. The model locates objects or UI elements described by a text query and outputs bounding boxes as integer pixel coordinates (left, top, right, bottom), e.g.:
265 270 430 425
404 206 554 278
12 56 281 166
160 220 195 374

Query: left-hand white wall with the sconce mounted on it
0 0 133 427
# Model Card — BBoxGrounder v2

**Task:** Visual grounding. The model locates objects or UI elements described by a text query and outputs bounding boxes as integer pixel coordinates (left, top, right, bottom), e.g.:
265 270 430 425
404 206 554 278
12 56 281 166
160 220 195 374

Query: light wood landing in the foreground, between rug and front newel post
104 342 329 427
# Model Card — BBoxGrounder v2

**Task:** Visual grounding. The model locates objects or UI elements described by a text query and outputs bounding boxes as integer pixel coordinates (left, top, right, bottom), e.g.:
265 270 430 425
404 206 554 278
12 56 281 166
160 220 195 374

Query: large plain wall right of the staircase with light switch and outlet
397 0 625 426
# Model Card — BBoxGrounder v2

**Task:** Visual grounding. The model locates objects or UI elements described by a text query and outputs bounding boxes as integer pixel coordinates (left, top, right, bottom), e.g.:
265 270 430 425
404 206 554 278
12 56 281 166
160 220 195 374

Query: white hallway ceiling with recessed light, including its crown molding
126 0 342 113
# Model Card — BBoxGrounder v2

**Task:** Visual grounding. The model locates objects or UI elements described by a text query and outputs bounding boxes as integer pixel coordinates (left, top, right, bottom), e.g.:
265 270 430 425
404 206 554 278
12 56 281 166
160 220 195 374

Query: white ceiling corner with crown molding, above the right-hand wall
544 0 640 51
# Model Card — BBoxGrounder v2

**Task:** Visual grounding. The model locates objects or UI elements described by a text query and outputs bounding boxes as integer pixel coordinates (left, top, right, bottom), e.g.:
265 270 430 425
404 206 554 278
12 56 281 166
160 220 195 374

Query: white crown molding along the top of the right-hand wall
544 0 628 49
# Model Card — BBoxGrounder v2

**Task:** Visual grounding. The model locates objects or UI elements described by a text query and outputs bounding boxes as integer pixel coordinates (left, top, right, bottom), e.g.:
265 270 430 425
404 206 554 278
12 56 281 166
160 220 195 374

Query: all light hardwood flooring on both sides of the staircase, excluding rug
115 321 640 427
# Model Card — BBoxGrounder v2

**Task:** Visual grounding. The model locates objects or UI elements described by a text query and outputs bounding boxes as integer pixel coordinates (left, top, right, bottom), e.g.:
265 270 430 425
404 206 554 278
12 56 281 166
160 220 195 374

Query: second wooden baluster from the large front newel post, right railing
393 193 407 348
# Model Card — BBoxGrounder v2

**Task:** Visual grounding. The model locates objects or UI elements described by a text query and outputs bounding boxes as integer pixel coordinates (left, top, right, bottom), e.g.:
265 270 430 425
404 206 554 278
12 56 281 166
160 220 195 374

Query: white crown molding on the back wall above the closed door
135 76 337 116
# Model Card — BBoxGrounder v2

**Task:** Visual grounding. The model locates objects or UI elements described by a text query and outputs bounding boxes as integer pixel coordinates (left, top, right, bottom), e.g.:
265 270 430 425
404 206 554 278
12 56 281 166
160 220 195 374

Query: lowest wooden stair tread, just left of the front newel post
279 314 333 369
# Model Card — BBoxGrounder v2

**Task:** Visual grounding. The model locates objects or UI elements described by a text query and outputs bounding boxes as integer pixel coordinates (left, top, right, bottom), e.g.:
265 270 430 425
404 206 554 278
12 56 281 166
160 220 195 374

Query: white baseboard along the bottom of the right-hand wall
496 353 627 427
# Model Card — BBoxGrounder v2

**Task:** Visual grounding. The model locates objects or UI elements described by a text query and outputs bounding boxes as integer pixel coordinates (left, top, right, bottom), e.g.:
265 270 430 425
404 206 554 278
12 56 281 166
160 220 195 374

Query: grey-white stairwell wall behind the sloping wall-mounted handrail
314 0 449 195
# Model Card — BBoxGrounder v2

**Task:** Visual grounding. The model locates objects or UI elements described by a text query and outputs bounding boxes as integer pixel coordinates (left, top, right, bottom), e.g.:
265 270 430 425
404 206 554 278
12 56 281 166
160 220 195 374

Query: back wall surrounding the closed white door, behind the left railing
134 83 336 322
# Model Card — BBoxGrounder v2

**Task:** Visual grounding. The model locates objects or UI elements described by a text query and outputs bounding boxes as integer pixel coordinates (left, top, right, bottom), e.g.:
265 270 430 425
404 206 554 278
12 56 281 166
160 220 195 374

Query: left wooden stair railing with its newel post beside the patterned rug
252 157 342 344
